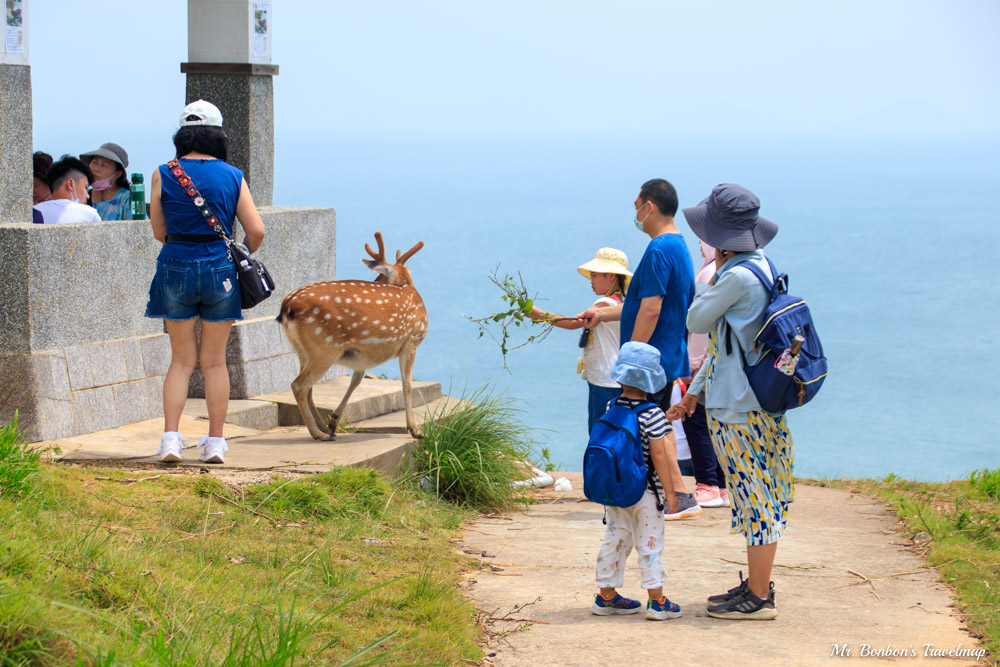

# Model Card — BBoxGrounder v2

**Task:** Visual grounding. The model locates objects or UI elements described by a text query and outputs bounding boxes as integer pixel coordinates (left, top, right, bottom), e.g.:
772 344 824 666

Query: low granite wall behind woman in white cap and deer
0 207 345 440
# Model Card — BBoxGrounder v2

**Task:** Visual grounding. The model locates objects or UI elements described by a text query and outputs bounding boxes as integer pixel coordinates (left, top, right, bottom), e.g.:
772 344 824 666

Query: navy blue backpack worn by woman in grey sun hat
726 259 826 412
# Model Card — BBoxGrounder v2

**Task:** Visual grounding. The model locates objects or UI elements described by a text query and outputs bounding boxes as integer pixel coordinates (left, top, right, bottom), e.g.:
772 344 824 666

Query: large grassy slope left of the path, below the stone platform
0 466 481 667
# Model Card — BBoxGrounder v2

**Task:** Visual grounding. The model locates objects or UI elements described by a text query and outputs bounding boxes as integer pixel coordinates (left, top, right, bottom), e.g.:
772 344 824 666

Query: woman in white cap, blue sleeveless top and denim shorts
146 100 264 463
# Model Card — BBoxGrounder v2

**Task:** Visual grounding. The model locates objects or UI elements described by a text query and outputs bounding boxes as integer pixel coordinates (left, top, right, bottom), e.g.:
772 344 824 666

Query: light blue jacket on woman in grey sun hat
687 250 771 424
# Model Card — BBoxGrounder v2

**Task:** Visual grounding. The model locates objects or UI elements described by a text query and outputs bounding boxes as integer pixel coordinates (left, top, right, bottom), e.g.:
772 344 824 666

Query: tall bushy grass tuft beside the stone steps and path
411 387 545 512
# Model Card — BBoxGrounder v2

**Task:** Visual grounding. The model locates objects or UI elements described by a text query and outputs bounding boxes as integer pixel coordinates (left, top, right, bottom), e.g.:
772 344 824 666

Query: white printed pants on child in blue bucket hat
597 490 666 590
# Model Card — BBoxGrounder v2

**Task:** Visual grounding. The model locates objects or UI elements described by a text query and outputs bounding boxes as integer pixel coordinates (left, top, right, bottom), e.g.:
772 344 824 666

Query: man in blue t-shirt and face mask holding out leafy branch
579 178 701 519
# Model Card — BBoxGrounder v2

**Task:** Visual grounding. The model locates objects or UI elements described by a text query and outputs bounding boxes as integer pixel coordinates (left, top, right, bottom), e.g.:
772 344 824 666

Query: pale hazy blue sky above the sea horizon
27 0 1000 153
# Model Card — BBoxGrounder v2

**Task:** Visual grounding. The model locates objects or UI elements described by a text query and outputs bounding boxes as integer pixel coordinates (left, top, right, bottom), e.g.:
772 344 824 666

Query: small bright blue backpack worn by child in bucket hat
583 402 663 511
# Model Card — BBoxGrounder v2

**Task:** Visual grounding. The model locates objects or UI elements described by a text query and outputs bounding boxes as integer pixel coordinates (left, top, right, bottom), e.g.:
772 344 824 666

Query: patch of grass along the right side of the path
805 468 1000 664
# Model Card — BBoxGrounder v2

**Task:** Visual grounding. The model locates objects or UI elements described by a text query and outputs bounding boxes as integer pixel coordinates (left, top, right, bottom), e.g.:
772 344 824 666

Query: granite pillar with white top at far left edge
0 0 32 222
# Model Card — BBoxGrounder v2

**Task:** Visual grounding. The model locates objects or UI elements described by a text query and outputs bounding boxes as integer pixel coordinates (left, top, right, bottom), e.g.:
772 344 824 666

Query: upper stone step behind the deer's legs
252 376 442 426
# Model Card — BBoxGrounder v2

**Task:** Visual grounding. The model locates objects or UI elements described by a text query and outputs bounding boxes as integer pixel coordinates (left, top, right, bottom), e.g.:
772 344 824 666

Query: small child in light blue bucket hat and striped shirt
591 342 681 621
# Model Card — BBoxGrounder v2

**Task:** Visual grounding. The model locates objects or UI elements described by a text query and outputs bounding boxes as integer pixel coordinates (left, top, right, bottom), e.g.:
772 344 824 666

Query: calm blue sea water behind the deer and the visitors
275 130 1000 480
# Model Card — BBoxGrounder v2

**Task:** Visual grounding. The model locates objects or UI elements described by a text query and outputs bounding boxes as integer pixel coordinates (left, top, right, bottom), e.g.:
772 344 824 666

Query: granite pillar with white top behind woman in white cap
181 0 278 206
